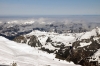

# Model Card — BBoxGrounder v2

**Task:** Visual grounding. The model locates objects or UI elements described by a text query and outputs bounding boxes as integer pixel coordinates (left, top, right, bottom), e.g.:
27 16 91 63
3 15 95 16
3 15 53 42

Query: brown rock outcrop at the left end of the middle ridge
14 35 42 47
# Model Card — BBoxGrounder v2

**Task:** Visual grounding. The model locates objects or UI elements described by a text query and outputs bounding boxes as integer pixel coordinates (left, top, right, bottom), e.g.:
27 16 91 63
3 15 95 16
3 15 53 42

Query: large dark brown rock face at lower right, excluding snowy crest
56 36 100 66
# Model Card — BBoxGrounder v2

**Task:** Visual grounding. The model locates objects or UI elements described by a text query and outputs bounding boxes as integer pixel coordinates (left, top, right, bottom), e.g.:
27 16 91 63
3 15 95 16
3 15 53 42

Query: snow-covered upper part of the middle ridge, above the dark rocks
14 27 100 50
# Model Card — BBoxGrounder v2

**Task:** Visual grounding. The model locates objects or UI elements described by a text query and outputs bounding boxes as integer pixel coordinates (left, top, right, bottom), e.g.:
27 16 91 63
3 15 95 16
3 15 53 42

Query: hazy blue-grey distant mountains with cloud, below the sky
0 16 100 40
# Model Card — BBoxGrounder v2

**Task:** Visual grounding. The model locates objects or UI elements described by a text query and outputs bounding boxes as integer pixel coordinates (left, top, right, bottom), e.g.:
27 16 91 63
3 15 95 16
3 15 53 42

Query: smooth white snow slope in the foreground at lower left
0 36 80 66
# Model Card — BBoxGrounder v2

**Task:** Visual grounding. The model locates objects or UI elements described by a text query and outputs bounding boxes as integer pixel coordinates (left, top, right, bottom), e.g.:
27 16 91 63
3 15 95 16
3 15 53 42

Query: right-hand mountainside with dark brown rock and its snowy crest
56 28 100 66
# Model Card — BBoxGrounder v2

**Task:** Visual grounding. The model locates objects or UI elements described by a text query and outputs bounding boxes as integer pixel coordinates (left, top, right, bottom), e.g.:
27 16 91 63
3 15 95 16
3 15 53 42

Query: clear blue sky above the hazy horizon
0 0 100 16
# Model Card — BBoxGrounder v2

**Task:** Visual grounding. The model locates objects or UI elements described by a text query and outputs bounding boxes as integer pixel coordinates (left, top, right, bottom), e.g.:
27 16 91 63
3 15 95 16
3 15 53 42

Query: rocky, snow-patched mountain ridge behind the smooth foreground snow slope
14 27 100 66
